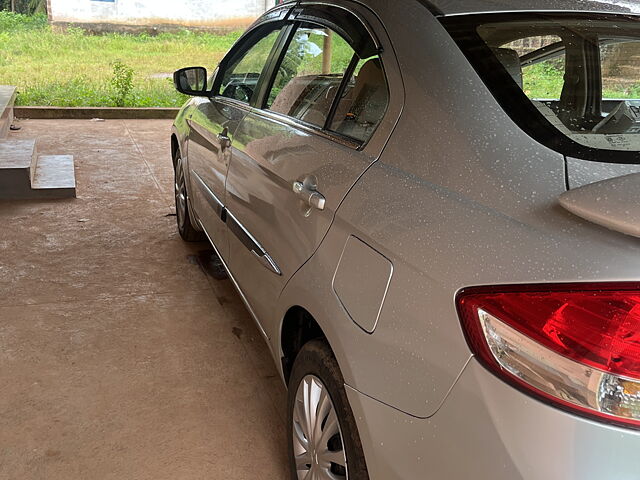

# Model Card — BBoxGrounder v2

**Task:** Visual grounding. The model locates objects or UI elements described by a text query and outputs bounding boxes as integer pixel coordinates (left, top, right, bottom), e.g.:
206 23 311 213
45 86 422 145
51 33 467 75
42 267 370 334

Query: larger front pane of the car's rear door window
266 24 355 127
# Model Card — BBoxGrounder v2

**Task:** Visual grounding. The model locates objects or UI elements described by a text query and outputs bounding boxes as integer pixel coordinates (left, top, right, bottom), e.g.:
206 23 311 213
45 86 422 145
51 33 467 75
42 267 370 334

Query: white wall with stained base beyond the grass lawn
49 0 275 26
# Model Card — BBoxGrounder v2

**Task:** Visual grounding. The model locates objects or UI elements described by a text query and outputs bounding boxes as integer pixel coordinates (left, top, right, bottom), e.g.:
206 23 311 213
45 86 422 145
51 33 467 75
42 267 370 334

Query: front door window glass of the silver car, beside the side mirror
220 30 280 103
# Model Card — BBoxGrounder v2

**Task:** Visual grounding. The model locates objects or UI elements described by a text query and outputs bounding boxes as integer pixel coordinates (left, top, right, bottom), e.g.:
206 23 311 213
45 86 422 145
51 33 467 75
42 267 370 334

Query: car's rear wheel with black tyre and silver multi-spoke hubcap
287 340 369 480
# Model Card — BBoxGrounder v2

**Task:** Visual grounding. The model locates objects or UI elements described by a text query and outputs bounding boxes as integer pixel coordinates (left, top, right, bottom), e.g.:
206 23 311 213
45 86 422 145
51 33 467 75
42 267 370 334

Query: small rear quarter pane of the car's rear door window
330 55 389 142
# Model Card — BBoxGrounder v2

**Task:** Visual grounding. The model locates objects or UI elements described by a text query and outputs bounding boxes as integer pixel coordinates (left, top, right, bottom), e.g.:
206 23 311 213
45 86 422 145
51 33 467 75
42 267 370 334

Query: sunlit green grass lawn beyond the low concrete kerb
0 11 241 107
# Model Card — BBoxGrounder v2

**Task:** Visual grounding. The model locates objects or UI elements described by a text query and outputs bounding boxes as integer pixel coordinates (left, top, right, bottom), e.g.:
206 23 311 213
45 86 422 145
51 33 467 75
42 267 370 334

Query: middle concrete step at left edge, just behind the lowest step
0 140 36 198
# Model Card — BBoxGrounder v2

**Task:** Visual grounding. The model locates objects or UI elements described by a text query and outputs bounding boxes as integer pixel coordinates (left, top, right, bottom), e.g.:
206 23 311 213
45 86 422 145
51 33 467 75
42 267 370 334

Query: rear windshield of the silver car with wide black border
443 13 640 163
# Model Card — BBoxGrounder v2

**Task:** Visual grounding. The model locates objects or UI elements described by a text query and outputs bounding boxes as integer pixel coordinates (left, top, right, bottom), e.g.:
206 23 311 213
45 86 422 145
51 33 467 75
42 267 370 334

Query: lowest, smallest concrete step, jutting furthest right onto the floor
31 155 76 198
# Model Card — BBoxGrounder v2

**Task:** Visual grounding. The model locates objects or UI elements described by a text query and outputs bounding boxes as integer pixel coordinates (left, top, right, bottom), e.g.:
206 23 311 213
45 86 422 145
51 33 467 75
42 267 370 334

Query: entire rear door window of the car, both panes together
266 24 389 142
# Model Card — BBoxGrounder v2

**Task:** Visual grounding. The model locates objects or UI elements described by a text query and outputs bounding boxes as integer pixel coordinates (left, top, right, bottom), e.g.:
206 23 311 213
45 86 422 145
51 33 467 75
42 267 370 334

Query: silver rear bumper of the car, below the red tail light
347 359 640 480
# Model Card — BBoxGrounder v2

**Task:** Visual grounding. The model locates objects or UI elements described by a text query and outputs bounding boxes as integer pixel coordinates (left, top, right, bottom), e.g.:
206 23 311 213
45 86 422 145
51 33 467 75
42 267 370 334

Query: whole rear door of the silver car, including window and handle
226 2 403 336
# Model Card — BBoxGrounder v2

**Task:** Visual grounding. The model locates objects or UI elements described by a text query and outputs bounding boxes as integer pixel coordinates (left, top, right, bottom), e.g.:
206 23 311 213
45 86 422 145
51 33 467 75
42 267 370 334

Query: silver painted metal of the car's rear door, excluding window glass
226 1 404 338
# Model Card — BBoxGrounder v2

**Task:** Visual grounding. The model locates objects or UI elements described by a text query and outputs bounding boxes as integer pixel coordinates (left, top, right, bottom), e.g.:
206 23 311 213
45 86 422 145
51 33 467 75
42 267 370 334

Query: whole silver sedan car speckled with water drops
171 0 640 480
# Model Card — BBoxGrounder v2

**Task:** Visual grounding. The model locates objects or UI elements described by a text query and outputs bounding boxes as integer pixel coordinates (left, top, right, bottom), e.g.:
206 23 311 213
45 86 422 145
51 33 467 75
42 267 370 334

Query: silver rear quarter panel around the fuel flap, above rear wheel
281 2 640 417
